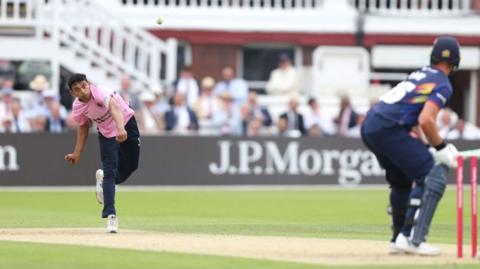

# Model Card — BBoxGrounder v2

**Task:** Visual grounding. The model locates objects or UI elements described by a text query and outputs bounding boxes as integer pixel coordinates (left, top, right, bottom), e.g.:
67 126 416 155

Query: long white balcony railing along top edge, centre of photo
118 0 324 9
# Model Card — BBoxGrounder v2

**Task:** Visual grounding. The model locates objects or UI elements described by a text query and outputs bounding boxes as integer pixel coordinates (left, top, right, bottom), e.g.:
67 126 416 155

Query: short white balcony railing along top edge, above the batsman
350 0 472 15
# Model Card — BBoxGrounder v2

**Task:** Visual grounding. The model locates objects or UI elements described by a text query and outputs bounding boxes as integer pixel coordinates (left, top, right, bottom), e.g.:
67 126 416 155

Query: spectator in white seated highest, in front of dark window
266 54 300 96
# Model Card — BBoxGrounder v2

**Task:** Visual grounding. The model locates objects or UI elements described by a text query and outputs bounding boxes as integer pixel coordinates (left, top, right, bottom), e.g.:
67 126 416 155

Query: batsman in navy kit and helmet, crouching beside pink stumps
361 36 460 256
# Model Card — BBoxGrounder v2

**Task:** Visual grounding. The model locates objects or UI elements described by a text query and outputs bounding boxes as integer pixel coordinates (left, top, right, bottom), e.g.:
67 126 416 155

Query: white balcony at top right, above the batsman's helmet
351 0 480 36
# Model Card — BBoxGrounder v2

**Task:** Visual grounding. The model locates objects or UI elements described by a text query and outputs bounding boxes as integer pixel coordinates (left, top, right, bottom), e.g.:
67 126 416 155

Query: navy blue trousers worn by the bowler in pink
99 116 140 218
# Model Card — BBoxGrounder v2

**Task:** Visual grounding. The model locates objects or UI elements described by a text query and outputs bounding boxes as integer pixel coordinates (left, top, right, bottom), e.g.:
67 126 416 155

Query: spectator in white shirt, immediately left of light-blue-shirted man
193 77 221 119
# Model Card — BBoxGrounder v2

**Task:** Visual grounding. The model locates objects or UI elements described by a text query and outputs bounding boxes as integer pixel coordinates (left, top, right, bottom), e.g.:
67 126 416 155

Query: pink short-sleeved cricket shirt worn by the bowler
72 84 134 138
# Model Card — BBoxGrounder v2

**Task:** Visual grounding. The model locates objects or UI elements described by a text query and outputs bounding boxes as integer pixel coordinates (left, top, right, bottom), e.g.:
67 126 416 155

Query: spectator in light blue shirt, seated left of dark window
213 66 248 105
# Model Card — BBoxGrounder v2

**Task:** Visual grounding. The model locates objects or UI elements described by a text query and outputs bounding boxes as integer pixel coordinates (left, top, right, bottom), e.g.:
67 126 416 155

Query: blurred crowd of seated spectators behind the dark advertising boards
0 55 480 139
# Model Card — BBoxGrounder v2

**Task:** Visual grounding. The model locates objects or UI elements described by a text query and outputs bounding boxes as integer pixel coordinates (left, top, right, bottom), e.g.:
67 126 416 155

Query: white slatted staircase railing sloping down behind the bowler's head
0 0 177 91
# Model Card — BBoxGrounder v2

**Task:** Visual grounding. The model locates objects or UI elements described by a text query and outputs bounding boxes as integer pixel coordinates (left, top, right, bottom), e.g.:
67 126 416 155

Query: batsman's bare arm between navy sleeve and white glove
418 101 445 150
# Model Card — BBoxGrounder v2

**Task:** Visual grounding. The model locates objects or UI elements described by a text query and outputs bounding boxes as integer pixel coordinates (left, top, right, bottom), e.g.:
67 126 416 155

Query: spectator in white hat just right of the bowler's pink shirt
136 91 164 134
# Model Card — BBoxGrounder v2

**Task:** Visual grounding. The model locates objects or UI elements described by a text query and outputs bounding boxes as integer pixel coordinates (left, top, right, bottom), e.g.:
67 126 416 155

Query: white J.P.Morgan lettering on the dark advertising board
209 140 385 185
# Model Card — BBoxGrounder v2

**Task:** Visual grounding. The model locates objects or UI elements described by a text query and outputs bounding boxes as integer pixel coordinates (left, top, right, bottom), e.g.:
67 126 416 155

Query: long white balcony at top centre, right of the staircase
99 0 357 33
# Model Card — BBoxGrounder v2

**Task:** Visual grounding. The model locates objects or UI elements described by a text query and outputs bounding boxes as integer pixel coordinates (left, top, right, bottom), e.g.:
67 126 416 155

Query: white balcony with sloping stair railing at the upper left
0 0 177 89
